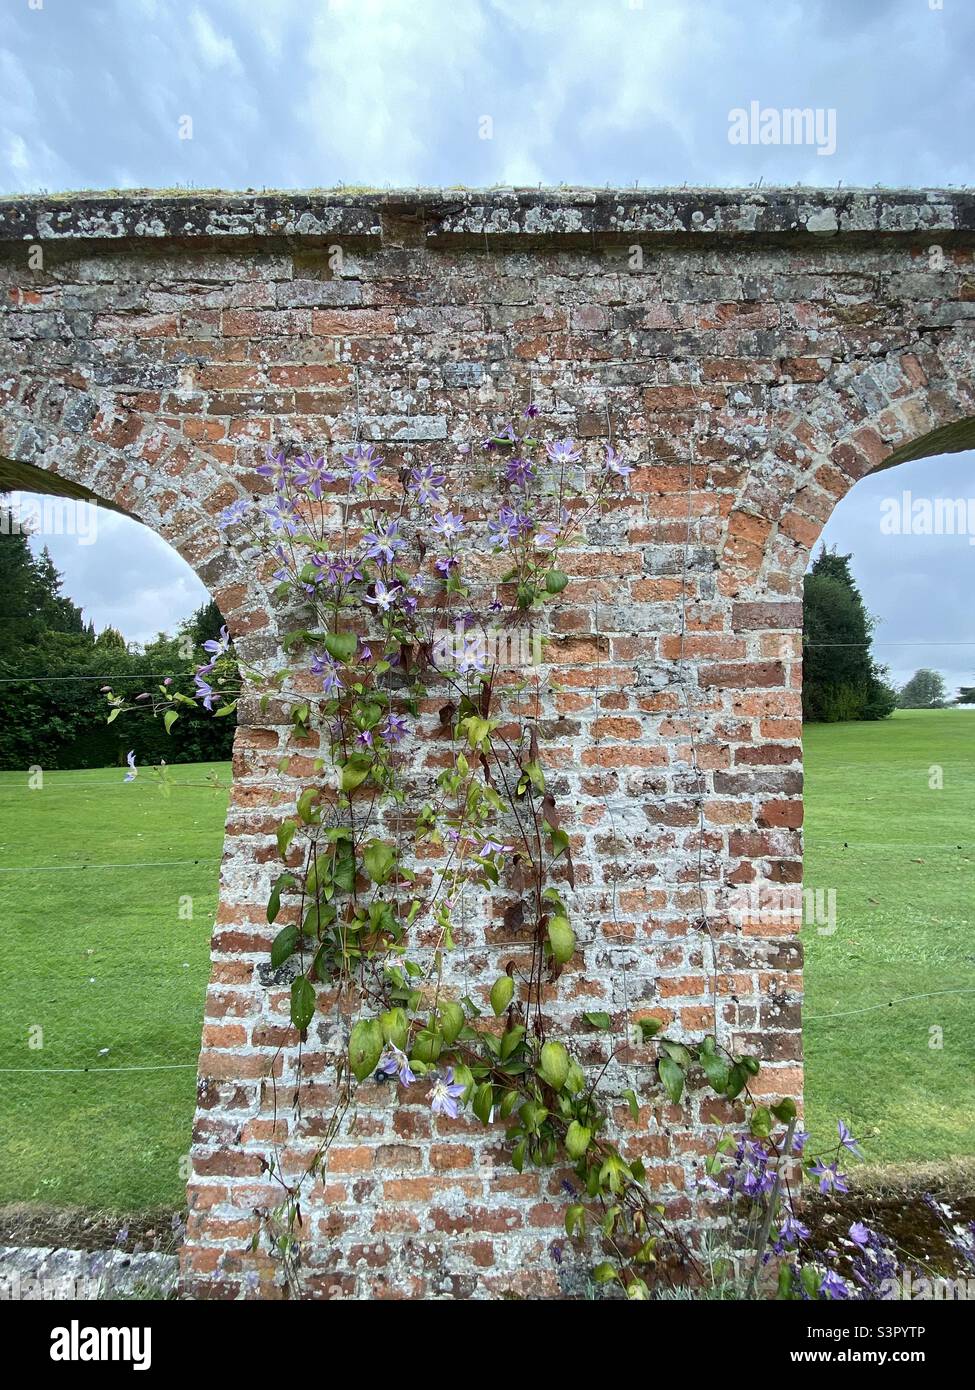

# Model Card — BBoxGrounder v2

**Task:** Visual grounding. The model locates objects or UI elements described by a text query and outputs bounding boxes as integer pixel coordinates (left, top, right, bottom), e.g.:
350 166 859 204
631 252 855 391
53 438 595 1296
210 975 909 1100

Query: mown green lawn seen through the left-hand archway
0 765 228 1211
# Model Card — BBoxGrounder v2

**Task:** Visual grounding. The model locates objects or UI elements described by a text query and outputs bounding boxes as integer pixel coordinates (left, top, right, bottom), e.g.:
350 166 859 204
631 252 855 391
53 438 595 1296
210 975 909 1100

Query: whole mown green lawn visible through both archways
0 710 975 1211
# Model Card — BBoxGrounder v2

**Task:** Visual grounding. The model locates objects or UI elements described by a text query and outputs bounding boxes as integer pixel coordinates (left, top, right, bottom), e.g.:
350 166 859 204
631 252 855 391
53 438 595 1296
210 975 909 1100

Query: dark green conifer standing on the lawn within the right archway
803 548 897 723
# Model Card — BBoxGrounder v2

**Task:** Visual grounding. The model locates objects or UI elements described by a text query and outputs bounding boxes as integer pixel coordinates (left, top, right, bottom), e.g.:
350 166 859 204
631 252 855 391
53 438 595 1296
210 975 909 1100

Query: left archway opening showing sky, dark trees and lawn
0 472 235 1248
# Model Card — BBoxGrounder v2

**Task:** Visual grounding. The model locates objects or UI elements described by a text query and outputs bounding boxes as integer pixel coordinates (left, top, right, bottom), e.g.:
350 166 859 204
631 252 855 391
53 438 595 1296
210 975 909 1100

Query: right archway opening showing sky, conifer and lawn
803 420 975 1190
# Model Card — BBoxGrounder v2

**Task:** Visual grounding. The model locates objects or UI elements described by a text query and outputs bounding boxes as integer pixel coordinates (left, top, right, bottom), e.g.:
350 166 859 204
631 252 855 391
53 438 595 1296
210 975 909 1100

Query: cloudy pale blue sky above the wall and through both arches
0 0 975 685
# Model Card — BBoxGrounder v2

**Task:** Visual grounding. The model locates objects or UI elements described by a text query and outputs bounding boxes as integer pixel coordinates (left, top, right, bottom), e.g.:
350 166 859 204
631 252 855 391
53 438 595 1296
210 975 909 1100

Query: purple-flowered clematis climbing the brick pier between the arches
107 406 906 1300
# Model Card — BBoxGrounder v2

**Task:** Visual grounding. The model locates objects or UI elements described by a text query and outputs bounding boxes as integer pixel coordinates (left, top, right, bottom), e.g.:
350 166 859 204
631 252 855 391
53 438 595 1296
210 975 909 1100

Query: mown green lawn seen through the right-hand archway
803 709 975 1162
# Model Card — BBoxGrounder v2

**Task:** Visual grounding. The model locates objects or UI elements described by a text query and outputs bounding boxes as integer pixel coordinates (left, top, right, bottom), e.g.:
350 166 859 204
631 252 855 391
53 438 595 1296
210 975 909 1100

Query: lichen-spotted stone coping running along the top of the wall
0 188 975 247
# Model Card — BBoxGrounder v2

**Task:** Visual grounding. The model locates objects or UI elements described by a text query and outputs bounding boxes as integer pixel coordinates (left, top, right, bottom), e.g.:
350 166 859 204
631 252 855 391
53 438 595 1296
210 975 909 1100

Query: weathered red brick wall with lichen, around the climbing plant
0 190 975 1297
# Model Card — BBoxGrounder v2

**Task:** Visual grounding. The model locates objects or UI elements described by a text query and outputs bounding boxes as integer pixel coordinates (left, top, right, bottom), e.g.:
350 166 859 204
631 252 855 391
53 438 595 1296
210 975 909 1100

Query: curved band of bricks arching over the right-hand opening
722 328 975 598
